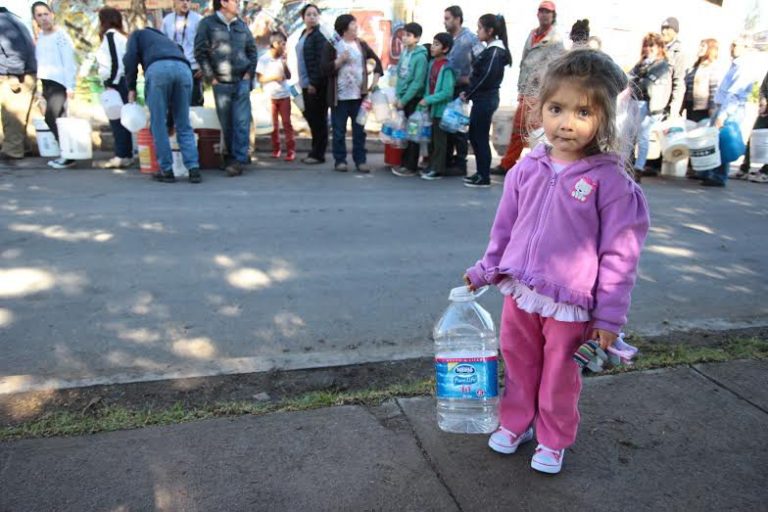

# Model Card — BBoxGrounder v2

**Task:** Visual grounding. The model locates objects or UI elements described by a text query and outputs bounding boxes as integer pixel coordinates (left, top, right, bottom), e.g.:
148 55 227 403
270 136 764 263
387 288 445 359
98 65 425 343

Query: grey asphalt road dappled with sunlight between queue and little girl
0 155 768 393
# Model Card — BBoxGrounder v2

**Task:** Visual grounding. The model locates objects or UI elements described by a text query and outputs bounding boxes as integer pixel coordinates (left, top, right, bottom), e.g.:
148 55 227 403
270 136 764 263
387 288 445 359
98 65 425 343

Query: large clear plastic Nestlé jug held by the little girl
433 286 499 434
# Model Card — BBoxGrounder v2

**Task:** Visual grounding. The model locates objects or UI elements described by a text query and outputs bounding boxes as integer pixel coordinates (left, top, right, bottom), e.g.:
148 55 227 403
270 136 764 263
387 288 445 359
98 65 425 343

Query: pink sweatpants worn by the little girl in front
499 296 589 450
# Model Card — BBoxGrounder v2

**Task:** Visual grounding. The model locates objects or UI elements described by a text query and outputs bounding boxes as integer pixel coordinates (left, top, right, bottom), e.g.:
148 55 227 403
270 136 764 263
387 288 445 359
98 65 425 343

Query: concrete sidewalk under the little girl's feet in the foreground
0 361 768 512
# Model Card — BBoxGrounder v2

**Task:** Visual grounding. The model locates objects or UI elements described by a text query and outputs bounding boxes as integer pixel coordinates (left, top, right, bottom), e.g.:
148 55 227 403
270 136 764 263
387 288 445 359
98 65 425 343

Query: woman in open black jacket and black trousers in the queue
296 4 328 164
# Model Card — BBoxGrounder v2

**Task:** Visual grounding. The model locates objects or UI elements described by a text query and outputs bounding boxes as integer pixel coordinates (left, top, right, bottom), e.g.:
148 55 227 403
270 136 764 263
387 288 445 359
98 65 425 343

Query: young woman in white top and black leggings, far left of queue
32 2 77 169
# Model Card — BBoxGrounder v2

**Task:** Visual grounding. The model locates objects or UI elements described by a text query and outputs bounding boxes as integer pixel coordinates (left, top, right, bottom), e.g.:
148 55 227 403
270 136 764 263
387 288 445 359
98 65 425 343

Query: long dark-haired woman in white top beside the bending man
96 7 133 169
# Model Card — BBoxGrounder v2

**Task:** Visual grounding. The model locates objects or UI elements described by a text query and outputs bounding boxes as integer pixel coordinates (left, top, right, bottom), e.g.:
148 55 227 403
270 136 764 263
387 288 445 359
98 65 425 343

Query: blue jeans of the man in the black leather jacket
213 80 251 164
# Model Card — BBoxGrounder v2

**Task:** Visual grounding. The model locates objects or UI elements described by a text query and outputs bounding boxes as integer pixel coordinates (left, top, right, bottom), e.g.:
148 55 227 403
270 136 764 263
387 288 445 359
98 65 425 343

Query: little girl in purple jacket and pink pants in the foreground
464 49 649 473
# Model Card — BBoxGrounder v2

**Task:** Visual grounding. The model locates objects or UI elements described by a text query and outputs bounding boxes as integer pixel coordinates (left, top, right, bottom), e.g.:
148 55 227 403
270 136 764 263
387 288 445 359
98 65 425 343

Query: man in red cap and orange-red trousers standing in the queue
493 2 565 174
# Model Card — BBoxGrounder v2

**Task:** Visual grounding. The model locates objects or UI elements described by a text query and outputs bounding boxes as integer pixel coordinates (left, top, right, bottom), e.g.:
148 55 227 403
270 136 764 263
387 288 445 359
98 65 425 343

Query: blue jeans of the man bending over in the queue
144 60 200 172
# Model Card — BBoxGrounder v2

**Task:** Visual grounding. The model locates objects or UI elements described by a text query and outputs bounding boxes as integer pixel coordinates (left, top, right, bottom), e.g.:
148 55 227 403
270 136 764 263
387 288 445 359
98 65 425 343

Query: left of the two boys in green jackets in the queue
392 23 427 176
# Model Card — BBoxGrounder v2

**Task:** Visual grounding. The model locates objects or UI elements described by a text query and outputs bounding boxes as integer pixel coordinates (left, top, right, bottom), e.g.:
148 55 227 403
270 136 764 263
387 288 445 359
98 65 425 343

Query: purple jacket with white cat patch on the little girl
467 144 650 333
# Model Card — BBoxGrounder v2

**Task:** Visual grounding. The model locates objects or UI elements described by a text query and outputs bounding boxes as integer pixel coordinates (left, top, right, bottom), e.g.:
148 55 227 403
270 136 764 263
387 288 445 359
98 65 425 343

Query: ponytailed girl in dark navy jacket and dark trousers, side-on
461 14 512 187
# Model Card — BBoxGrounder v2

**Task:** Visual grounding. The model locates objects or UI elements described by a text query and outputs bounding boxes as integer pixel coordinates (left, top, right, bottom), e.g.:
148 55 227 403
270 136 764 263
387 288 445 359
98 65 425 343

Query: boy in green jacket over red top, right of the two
419 32 456 180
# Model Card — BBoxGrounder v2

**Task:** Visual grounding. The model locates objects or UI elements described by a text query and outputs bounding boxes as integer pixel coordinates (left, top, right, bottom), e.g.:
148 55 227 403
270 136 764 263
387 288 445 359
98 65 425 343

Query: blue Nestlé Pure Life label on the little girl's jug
435 356 499 399
